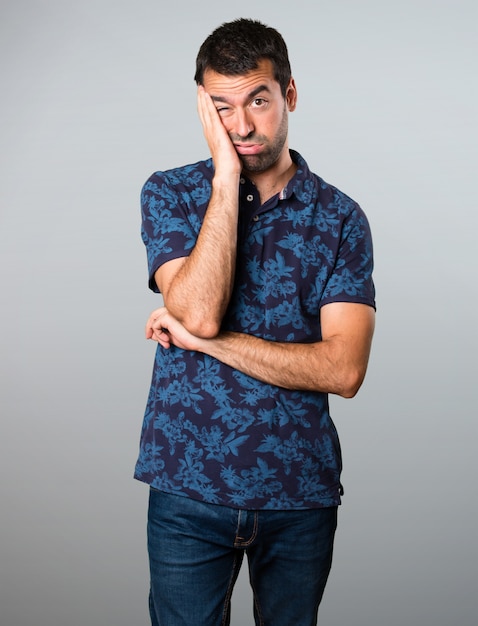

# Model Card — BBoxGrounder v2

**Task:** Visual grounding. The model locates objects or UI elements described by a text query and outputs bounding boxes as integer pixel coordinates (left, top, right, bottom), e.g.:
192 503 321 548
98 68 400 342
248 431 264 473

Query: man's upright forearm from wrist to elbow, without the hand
162 176 239 337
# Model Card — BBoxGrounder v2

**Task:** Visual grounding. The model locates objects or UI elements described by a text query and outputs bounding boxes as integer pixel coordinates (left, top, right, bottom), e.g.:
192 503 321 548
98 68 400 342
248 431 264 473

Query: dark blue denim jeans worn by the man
148 489 337 626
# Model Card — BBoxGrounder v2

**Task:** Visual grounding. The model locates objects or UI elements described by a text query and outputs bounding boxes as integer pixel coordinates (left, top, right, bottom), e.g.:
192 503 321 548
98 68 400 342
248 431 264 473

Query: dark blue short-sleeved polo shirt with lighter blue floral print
135 151 375 509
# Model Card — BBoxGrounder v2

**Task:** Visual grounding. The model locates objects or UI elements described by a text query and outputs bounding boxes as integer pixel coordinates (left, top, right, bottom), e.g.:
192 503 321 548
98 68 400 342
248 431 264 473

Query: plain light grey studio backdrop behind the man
0 0 478 626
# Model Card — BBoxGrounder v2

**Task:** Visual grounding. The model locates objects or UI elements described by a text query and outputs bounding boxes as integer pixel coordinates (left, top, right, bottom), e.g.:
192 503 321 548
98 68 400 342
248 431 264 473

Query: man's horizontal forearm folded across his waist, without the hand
198 332 368 397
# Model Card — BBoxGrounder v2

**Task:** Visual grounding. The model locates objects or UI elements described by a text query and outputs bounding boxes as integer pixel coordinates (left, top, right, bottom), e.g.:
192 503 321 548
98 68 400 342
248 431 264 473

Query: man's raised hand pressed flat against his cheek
198 85 242 176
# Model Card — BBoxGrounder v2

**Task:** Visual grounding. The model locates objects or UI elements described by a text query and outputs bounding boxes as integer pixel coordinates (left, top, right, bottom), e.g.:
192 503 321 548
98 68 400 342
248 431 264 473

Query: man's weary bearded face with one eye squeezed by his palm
204 59 297 173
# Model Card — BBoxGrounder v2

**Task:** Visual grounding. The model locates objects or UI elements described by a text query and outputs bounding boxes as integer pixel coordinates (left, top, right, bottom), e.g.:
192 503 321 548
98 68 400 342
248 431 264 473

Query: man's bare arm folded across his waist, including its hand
146 302 375 398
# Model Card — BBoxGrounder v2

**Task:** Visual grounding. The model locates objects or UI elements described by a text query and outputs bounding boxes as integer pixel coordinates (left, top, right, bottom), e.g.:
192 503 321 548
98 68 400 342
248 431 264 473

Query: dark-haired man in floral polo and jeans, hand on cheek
135 19 375 626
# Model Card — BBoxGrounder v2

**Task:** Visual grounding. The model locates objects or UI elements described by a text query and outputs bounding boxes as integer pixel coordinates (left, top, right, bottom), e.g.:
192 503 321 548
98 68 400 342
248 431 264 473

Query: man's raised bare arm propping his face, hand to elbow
155 87 241 338
